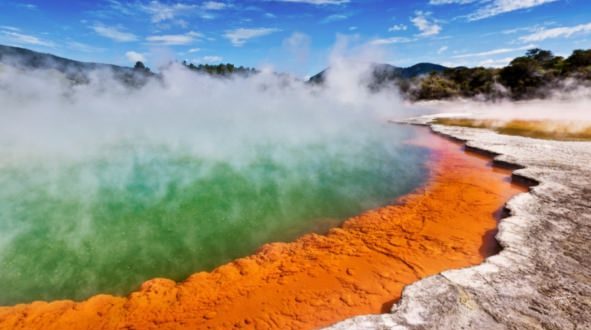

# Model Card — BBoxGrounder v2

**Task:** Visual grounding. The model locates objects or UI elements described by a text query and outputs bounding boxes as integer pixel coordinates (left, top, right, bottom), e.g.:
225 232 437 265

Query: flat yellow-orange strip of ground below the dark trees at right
433 118 591 141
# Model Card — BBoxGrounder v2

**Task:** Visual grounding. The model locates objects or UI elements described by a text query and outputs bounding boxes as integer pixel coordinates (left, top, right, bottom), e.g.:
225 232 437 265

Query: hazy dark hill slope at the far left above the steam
0 45 154 86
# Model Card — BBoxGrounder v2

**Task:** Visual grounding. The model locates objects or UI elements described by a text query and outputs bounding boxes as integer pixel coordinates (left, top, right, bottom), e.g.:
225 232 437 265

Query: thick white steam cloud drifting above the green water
0 56 414 157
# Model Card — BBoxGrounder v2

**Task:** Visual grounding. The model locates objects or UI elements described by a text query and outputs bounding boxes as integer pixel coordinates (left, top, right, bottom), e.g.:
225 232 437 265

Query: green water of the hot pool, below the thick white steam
0 128 426 305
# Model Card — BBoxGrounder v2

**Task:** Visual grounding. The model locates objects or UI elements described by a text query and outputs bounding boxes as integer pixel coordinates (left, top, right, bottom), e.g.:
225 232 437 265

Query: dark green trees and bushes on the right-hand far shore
398 48 591 100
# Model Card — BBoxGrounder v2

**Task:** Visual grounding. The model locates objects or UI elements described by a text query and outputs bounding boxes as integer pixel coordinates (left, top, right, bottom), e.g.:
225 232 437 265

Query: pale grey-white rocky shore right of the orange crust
330 118 591 330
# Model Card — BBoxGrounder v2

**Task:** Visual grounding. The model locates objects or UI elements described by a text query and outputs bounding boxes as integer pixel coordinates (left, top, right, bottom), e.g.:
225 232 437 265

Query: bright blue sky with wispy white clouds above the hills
0 0 591 76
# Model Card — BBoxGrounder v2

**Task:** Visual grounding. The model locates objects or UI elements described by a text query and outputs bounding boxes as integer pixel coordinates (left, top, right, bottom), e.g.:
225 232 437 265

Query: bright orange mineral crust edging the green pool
0 130 524 330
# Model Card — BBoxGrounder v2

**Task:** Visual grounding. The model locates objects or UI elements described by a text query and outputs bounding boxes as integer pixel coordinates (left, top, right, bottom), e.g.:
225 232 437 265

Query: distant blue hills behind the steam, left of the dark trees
309 63 448 87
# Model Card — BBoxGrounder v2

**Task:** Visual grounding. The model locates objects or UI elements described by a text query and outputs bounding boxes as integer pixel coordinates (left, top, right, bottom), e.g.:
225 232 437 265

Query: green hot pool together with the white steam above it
0 62 425 305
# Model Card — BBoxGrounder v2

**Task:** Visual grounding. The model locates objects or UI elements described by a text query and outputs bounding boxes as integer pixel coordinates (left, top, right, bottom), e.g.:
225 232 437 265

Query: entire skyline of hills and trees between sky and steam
0 45 591 101
